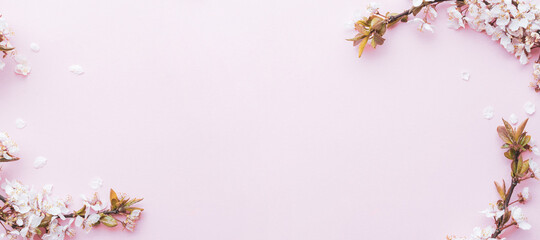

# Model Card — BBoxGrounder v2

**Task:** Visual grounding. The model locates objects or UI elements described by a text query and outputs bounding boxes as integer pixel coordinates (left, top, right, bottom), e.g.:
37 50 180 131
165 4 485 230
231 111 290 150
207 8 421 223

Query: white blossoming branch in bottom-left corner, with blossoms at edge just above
0 132 144 240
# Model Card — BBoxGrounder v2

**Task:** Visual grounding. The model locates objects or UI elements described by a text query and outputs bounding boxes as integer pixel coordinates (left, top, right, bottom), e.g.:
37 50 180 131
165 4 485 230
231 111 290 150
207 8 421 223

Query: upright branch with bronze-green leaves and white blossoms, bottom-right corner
447 120 540 240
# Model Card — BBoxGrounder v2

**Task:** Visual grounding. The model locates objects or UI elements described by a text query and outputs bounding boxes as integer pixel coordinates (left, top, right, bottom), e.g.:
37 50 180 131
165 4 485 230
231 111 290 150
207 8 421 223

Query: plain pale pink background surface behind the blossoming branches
0 0 540 240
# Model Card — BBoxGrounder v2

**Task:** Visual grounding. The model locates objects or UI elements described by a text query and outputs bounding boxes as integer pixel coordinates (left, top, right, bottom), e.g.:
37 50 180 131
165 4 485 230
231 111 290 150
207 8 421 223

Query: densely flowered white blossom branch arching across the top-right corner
347 0 540 92
